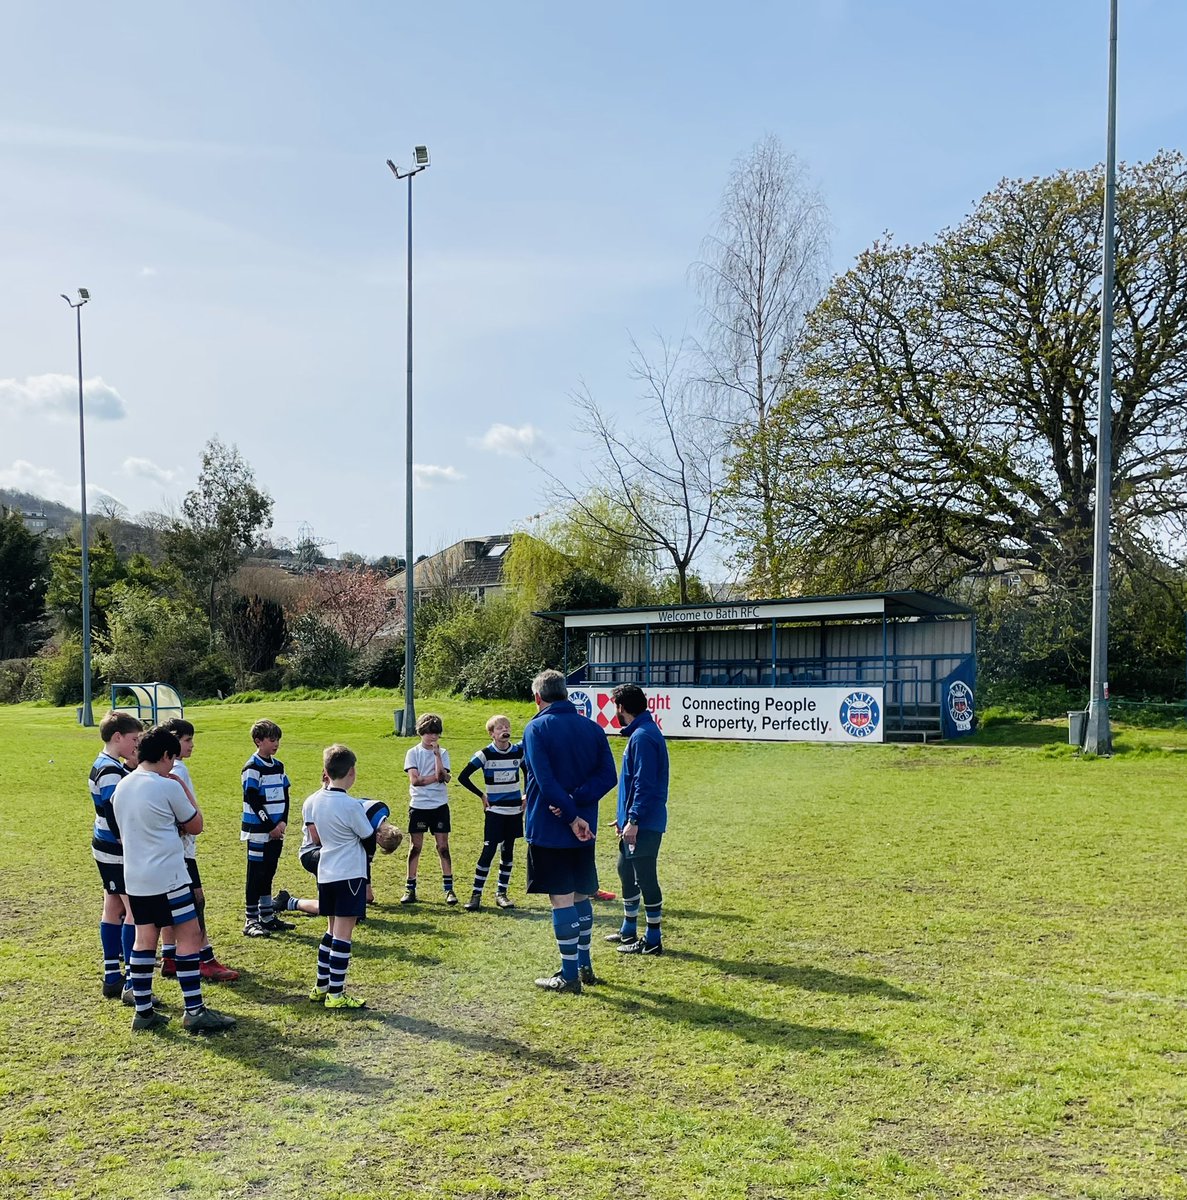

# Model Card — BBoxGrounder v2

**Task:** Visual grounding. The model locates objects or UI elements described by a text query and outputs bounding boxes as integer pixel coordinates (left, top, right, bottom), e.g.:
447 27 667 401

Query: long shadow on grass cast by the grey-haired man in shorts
589 980 883 1055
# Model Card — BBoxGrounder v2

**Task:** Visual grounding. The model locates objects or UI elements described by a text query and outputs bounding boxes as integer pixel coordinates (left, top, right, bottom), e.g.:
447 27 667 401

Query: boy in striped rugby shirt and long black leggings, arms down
239 721 294 937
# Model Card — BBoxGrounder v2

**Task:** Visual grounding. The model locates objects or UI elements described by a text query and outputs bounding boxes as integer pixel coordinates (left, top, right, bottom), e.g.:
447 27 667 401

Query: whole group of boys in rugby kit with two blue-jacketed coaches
90 672 667 1033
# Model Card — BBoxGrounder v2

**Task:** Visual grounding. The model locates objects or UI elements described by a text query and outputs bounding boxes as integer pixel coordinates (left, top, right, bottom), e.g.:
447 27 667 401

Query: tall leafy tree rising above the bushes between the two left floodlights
164 438 272 637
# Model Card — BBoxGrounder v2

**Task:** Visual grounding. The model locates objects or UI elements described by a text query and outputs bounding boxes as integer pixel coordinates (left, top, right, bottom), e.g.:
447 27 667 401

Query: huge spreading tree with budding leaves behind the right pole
732 152 1187 596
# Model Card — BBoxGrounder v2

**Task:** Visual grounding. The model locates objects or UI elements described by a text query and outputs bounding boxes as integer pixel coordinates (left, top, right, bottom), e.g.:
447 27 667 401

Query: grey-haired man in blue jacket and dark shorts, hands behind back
523 671 618 994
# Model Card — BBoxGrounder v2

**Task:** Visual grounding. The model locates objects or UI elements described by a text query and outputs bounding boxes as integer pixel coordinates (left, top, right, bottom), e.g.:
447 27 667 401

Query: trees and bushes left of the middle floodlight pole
0 438 403 704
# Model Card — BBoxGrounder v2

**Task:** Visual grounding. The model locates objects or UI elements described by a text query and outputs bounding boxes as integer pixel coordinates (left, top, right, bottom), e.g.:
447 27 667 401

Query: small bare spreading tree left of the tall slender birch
546 342 720 604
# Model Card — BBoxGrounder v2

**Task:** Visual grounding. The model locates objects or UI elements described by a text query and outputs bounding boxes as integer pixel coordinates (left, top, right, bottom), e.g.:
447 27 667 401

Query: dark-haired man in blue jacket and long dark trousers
606 683 667 955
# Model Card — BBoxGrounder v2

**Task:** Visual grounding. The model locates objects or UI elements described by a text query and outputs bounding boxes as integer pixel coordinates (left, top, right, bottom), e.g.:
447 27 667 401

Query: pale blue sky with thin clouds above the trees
0 0 1187 554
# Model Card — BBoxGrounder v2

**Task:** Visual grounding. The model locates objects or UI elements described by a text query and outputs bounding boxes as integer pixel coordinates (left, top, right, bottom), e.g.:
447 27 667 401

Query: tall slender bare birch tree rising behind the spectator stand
693 136 828 595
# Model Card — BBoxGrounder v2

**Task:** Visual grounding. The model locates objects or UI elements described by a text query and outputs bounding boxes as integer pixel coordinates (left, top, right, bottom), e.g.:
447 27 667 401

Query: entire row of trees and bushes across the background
0 138 1187 698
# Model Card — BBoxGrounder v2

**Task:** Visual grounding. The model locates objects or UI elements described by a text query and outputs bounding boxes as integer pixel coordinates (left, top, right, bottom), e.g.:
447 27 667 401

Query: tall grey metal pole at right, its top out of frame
1084 0 1117 754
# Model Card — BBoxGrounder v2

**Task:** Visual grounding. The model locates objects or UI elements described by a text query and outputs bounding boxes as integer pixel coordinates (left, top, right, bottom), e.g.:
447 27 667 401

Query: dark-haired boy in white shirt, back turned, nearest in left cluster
112 726 235 1033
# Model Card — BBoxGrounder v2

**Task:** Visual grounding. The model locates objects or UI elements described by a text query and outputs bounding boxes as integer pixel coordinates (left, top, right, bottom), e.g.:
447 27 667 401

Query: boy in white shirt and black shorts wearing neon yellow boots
302 745 374 1009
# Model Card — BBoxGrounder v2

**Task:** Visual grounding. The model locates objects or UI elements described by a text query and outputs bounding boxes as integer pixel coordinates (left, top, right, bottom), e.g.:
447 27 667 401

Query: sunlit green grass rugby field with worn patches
0 698 1187 1200
